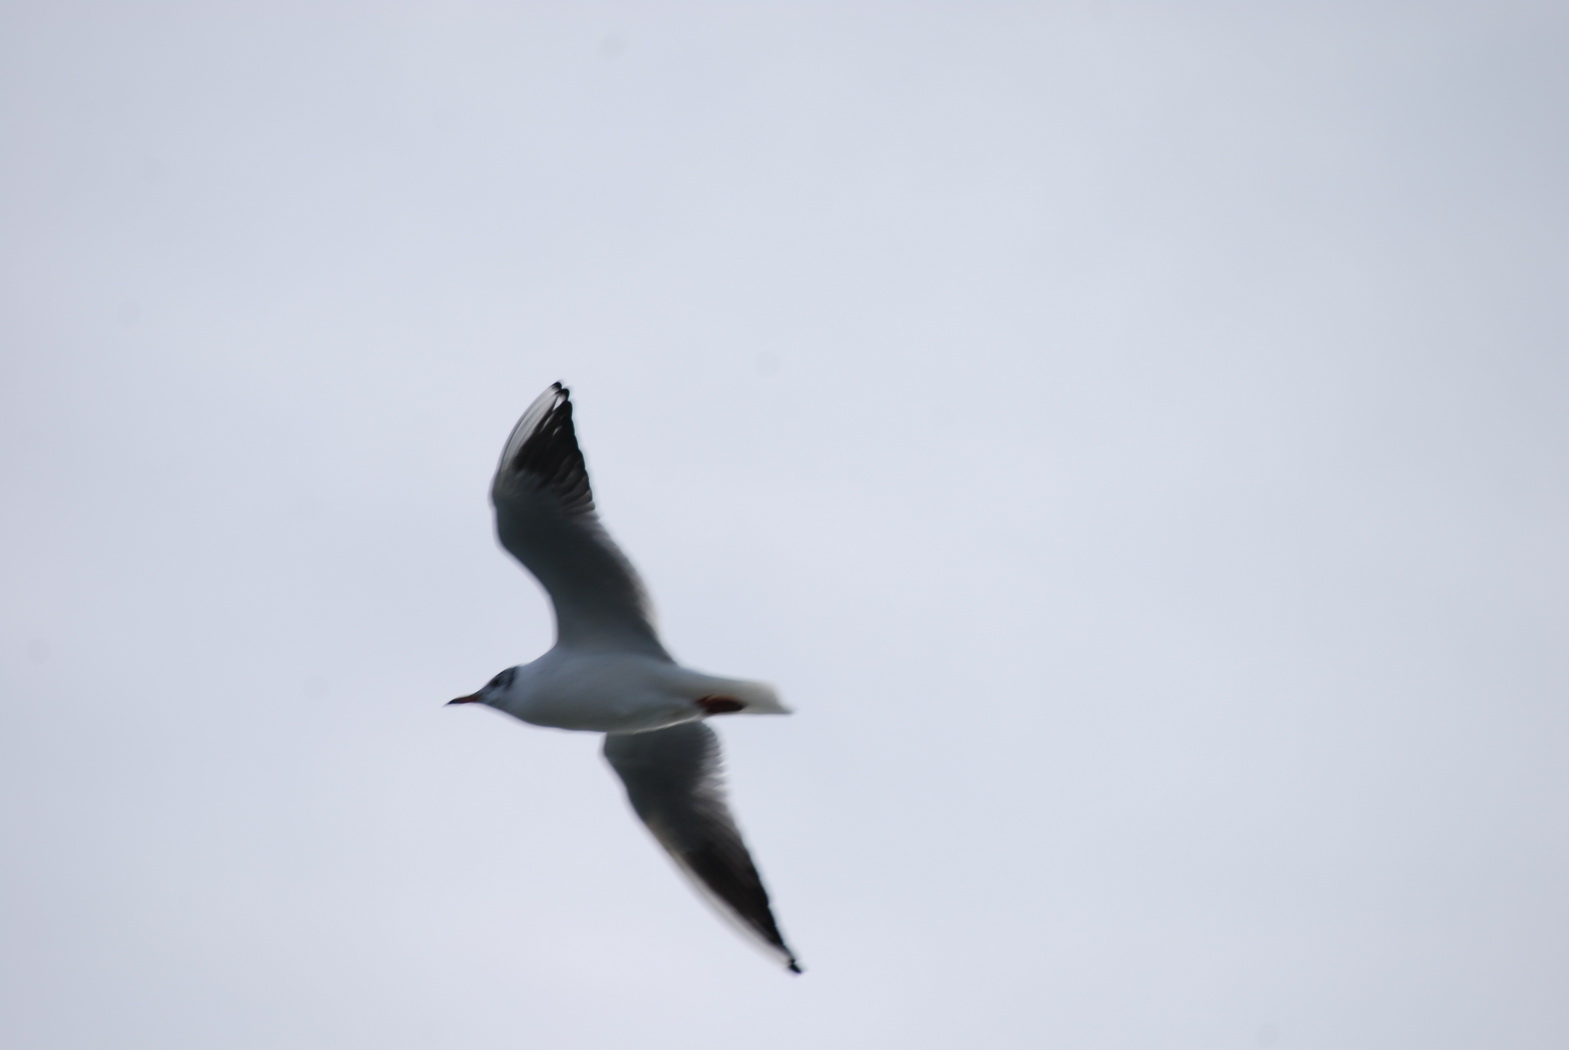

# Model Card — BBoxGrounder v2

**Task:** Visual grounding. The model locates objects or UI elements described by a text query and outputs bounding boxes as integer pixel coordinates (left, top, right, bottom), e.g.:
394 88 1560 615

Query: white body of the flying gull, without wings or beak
485 645 789 733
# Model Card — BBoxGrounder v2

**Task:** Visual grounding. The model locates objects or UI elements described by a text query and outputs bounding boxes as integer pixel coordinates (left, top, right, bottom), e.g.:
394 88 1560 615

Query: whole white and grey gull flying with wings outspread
449 383 800 973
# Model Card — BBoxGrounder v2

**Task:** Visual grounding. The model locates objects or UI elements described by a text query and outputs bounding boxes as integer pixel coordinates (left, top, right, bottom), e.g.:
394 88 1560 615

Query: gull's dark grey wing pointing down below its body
604 722 800 973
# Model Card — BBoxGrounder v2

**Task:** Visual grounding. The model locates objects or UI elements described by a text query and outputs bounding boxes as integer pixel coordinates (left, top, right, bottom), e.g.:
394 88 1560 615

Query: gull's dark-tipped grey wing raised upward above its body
491 383 665 656
